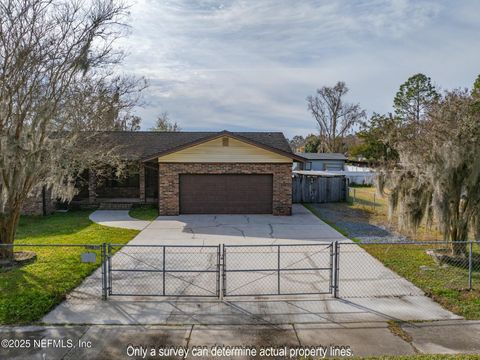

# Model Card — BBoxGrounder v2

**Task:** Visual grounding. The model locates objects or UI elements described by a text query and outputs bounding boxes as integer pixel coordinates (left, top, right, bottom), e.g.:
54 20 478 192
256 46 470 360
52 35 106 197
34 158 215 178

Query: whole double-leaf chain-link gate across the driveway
102 243 338 298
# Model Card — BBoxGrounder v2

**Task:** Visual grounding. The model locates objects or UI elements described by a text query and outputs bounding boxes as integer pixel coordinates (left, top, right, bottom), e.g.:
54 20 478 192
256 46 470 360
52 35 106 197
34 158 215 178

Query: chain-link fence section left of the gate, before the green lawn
0 243 104 311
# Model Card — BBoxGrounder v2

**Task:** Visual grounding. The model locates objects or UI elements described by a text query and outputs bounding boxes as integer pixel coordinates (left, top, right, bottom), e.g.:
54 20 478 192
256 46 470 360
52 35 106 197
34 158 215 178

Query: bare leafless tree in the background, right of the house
307 81 366 152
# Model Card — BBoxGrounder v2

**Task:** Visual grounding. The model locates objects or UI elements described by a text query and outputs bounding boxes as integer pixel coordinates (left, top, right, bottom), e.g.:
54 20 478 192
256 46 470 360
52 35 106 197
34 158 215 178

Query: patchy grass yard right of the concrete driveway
305 187 480 320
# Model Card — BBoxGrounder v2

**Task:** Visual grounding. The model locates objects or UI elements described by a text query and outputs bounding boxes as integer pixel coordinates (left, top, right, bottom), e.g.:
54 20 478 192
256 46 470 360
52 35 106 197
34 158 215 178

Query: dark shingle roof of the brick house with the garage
88 131 293 160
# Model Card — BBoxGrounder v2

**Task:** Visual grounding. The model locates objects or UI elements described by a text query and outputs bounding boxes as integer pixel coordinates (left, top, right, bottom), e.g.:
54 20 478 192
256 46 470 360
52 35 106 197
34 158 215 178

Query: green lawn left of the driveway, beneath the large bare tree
0 211 138 325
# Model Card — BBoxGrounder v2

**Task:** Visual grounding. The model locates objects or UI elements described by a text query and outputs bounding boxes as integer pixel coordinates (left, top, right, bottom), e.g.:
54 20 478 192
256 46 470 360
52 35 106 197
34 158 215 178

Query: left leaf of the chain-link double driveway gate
107 244 220 297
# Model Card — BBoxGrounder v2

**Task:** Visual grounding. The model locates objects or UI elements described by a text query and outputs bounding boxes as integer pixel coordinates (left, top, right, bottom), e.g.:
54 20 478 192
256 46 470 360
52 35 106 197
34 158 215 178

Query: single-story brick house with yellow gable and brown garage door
24 131 304 215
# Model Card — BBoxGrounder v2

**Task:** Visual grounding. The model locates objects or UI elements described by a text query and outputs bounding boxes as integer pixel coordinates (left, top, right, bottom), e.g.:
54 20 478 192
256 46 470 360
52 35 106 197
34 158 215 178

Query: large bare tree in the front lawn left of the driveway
0 0 142 260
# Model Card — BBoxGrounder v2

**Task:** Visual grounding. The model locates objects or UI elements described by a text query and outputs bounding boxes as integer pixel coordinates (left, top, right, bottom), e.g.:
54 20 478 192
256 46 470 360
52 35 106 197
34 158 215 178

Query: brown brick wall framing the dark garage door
158 163 292 215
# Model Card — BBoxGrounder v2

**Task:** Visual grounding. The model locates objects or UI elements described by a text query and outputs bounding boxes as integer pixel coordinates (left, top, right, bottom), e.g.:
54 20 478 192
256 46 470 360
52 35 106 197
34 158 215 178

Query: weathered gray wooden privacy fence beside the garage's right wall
292 175 348 203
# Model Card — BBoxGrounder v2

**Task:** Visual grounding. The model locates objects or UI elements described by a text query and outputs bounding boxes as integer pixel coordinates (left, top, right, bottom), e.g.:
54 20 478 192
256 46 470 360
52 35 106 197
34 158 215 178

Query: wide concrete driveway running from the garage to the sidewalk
43 205 458 325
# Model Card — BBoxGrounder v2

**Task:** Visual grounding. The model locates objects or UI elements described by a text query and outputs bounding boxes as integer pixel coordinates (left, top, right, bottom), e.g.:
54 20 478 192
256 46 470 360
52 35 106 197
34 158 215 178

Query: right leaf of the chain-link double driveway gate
223 243 334 296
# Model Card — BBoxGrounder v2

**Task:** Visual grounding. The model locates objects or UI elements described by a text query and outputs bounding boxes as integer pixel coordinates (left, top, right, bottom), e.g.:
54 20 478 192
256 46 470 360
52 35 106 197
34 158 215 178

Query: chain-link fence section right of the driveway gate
337 242 480 298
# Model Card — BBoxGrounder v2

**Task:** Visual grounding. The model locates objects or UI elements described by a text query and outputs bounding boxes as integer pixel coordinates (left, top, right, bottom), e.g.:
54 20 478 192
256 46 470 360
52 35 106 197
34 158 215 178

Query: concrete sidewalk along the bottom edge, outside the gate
0 320 480 360
